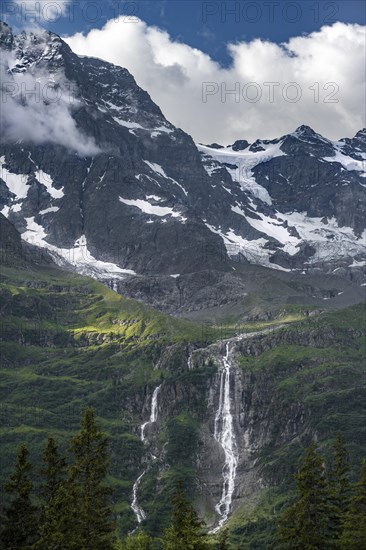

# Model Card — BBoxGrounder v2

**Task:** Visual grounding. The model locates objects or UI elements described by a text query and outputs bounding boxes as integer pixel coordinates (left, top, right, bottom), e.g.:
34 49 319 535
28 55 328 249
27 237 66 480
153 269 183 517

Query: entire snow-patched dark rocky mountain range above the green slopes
0 23 366 309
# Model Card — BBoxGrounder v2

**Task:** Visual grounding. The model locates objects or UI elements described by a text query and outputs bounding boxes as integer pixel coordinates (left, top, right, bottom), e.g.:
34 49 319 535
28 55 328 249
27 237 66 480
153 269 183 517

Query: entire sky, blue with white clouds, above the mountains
1 0 366 144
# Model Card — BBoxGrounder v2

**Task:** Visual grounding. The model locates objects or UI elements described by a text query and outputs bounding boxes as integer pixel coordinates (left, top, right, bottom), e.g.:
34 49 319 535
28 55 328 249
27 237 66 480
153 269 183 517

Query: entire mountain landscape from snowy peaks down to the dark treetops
0 23 366 550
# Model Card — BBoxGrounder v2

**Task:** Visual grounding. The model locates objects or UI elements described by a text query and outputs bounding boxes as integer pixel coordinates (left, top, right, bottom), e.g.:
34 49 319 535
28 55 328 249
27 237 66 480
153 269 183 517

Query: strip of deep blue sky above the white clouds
2 0 366 65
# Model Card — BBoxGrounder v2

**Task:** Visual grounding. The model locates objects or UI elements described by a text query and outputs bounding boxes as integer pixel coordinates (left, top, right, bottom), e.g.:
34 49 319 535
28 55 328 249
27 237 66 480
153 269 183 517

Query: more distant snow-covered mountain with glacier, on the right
198 126 366 269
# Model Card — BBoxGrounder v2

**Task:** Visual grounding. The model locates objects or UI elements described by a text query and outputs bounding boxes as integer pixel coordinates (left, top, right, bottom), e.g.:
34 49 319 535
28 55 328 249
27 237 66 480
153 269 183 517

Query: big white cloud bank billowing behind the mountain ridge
66 18 365 143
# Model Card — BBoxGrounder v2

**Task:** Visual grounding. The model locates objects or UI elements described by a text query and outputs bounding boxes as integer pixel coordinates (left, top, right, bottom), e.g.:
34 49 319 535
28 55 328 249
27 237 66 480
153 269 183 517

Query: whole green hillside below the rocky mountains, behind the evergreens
0 216 366 549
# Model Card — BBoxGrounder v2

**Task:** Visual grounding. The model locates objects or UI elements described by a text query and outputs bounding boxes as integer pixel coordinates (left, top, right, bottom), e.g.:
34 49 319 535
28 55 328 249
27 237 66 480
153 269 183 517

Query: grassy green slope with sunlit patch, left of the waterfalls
0 265 201 529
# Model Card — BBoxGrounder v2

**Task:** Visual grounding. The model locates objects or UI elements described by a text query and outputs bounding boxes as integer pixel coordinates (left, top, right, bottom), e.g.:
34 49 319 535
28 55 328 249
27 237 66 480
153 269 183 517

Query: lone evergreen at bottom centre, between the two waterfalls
163 481 208 550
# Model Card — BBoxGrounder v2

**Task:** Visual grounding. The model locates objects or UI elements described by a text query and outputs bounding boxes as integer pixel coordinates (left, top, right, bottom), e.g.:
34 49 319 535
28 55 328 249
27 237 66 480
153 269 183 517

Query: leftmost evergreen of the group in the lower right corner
277 442 336 550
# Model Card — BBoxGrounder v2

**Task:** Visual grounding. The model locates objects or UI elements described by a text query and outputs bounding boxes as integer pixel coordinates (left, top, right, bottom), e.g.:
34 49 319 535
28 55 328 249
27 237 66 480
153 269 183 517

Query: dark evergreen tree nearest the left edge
1 445 38 550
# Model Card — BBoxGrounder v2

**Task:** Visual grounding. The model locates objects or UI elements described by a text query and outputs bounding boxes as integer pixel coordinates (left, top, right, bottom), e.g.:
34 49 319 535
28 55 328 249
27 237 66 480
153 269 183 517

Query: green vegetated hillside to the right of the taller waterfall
229 304 366 550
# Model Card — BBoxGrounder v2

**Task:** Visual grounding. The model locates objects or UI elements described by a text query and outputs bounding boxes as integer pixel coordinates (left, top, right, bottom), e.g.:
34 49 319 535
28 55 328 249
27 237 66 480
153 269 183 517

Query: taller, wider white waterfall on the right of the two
211 342 238 533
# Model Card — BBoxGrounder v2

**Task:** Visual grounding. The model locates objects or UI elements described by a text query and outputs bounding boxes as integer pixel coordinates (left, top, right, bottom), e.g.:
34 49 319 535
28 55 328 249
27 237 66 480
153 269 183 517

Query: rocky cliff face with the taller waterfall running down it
128 314 365 530
